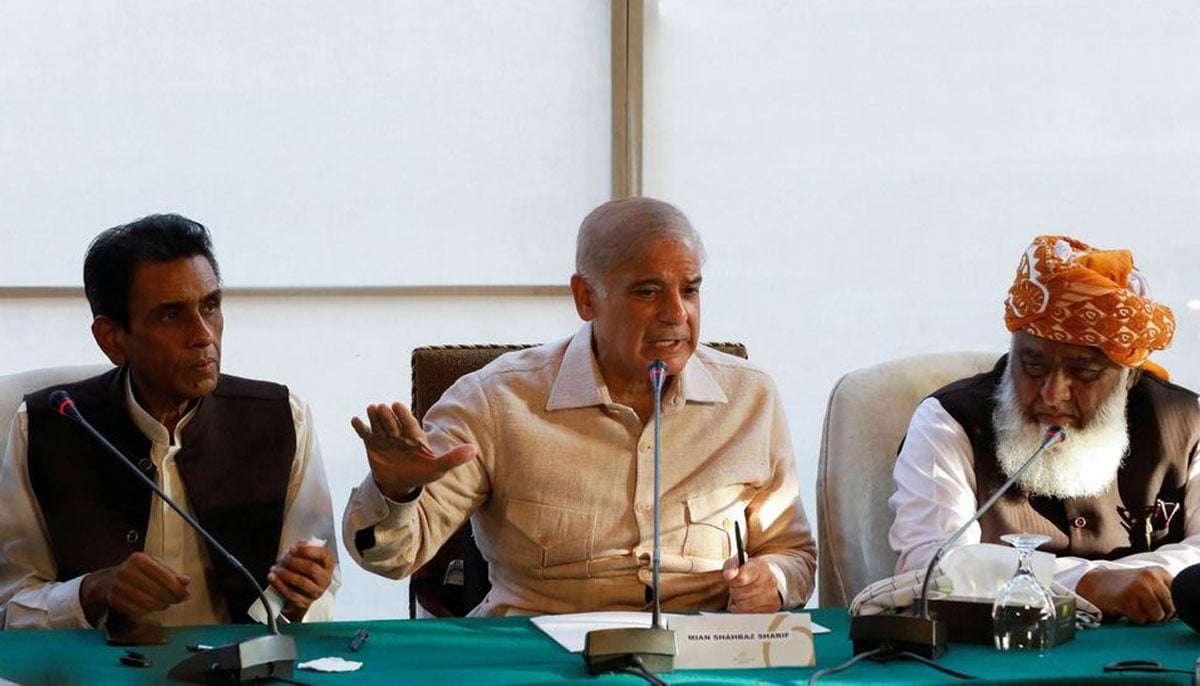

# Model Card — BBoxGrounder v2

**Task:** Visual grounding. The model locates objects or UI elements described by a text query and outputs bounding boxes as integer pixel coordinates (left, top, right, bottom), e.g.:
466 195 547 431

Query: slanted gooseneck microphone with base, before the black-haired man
49 389 300 684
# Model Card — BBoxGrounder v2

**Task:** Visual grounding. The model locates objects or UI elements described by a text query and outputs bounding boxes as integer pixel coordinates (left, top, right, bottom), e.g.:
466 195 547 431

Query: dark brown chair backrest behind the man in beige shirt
408 343 748 618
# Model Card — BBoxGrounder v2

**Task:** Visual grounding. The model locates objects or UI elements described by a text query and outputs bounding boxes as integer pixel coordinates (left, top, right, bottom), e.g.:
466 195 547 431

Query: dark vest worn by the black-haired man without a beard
25 368 296 622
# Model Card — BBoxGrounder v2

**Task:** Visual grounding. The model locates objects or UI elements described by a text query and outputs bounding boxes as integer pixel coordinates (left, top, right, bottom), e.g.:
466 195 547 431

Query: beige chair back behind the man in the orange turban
817 353 1000 607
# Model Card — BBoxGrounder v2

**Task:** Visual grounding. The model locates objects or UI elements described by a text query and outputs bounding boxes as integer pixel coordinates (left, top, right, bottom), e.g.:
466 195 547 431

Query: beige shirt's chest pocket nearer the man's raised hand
505 498 595 578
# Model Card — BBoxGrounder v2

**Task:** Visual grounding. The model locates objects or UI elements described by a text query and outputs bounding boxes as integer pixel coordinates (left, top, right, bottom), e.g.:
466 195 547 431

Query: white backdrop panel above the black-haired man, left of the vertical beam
0 0 612 287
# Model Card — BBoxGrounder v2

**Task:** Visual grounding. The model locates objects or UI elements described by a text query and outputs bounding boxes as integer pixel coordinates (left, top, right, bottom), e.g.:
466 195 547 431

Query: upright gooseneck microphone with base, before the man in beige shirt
583 360 676 674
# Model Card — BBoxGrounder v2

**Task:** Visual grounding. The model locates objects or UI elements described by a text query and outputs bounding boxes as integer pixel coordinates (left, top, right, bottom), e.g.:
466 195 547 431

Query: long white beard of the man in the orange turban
991 359 1129 499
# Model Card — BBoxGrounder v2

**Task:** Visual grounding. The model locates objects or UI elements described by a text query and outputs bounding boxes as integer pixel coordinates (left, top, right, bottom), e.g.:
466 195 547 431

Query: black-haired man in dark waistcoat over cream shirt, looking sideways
0 215 338 628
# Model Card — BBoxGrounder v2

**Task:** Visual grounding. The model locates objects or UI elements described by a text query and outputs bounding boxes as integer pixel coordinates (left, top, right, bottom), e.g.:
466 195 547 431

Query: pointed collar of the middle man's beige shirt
546 321 728 411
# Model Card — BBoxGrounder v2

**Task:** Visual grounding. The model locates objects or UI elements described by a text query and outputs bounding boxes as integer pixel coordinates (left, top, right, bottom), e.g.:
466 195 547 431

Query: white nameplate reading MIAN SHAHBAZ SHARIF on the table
671 612 816 669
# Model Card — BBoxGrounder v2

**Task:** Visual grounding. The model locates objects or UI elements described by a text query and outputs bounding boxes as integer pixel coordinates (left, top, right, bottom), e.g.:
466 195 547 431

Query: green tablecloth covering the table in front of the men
0 609 1200 686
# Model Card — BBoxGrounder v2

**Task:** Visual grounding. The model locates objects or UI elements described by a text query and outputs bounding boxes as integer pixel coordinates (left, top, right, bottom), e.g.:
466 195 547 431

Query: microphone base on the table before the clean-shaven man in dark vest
167 634 300 684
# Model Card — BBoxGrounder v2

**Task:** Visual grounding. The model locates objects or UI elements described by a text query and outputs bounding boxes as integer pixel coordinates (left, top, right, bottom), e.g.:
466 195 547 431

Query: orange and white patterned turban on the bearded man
1004 236 1175 378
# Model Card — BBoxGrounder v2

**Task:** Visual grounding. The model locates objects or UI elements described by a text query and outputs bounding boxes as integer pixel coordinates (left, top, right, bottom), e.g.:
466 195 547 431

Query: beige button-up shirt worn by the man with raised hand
342 325 816 615
